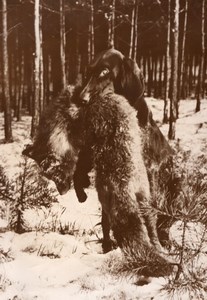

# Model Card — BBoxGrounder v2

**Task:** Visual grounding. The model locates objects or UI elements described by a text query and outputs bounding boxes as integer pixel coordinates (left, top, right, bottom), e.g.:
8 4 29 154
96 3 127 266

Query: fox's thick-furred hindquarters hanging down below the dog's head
82 93 160 249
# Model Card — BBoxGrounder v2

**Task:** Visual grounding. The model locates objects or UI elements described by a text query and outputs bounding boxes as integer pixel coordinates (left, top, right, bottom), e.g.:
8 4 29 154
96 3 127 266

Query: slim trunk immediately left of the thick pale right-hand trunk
163 0 171 123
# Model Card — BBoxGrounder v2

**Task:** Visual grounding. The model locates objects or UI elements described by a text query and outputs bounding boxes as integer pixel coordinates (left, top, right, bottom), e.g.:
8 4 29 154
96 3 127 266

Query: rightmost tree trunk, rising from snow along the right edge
196 0 206 112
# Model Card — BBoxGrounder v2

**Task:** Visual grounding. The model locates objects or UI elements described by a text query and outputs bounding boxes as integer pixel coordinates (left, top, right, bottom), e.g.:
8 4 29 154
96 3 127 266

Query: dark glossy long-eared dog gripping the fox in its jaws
80 49 173 164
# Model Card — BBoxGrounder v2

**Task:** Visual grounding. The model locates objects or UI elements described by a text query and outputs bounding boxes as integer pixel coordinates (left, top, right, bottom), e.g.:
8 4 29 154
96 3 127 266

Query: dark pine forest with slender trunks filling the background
0 0 207 142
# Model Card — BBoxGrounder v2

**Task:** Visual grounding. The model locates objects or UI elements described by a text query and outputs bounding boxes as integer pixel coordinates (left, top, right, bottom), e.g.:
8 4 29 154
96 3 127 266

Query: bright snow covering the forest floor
0 98 207 300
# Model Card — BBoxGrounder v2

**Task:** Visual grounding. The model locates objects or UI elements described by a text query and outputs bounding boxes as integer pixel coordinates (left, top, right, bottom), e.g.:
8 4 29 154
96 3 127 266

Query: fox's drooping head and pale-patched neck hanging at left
22 94 80 195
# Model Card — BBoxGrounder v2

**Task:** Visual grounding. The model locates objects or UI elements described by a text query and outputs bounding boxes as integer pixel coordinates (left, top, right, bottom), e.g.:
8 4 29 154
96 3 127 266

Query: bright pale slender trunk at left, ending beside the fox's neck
31 0 41 137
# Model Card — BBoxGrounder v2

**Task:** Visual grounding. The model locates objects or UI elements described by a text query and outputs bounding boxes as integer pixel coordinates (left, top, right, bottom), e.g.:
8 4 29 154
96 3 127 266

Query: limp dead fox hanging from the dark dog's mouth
23 87 174 274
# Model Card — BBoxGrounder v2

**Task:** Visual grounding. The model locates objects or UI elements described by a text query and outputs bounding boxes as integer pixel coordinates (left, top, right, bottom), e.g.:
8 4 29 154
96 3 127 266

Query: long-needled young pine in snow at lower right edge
157 151 207 299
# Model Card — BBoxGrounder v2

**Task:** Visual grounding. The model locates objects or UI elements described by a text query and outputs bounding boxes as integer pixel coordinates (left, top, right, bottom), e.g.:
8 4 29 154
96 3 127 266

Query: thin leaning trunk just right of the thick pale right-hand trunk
178 0 188 99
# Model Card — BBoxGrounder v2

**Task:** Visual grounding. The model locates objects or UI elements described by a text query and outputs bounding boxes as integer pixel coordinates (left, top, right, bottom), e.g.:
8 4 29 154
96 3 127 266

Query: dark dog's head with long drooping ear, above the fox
80 49 149 126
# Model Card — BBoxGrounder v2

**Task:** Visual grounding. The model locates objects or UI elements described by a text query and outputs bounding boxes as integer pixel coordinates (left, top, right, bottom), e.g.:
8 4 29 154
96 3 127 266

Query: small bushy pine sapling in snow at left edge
0 159 57 233
